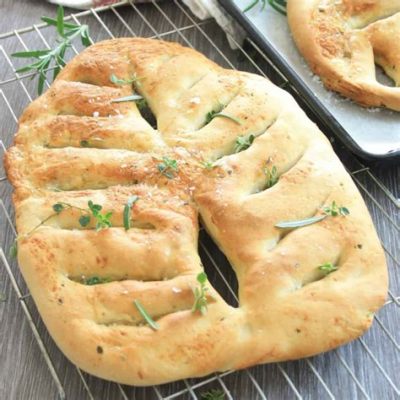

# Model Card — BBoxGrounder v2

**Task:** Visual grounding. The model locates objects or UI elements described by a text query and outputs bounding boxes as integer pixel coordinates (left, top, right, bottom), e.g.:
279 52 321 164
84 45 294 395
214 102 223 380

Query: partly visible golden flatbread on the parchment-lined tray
287 0 400 111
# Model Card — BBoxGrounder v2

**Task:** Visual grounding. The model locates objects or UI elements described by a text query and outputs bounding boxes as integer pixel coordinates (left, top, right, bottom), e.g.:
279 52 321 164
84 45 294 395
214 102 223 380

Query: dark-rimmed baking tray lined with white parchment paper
219 0 400 162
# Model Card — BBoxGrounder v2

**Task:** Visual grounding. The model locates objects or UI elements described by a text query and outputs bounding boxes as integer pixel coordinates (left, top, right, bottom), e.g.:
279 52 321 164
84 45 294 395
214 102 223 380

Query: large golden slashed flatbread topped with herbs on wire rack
5 38 387 385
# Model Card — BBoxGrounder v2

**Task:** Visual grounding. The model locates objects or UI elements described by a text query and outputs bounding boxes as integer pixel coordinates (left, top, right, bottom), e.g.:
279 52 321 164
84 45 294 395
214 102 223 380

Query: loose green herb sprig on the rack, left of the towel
12 6 91 95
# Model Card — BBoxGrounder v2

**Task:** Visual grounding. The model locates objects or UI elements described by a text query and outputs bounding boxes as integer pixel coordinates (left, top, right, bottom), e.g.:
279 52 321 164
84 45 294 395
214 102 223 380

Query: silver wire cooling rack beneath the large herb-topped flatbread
0 0 400 400
